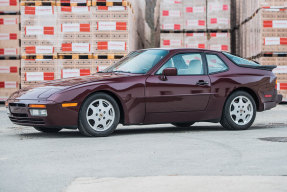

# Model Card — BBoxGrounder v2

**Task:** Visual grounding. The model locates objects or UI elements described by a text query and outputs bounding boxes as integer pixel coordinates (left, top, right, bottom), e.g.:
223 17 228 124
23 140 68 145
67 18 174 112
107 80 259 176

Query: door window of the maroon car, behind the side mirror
156 53 204 75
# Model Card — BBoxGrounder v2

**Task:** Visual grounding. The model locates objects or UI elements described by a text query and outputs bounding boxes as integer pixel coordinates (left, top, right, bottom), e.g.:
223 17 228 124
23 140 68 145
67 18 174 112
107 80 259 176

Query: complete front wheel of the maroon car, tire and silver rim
79 93 120 137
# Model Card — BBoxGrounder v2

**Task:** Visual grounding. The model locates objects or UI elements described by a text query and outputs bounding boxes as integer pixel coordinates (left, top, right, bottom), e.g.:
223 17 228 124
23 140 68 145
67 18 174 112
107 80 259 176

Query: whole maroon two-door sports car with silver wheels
6 49 282 136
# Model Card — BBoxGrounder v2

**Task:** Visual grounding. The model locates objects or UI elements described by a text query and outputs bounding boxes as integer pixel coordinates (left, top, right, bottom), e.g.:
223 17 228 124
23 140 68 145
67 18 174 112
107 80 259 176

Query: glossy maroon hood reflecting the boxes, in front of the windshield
9 73 127 100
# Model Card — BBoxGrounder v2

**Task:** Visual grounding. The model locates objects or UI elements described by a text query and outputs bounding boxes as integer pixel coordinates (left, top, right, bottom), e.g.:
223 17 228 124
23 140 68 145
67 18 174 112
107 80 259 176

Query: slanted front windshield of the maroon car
101 50 168 74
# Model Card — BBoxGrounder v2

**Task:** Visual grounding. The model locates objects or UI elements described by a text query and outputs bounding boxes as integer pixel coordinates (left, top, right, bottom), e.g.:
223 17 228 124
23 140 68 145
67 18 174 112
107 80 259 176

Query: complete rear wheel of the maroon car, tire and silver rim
220 91 256 130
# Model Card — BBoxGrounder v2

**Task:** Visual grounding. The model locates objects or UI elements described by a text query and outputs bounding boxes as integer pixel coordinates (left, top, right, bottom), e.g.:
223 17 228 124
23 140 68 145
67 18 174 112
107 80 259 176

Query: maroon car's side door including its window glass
145 53 211 113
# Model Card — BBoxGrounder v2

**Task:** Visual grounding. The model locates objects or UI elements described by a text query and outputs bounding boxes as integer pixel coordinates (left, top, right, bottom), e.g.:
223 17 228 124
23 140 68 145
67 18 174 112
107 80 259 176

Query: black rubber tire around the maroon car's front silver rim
78 93 120 137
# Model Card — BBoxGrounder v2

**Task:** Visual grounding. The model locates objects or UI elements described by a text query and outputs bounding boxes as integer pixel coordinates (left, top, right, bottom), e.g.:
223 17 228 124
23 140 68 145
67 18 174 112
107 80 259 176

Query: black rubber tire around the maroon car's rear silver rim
220 91 256 130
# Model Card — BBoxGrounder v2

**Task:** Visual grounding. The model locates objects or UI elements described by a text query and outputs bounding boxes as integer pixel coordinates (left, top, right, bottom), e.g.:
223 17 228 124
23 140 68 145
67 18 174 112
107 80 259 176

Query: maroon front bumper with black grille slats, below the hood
7 100 78 128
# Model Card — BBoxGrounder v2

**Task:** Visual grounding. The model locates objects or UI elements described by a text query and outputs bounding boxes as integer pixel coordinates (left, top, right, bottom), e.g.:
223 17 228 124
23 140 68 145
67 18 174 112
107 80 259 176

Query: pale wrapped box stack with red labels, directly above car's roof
160 0 231 52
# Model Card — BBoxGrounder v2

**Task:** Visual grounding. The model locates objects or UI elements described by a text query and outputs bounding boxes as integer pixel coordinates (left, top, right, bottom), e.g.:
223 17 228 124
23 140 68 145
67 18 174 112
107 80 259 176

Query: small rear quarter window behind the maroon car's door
206 54 228 74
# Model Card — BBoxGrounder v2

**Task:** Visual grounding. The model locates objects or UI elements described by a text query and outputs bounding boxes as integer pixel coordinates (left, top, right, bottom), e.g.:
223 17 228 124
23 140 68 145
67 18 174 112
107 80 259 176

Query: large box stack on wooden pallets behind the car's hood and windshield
21 0 135 87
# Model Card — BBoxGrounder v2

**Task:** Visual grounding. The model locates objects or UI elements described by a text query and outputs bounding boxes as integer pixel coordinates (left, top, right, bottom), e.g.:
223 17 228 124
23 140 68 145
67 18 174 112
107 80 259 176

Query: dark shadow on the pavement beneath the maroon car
16 125 277 139
